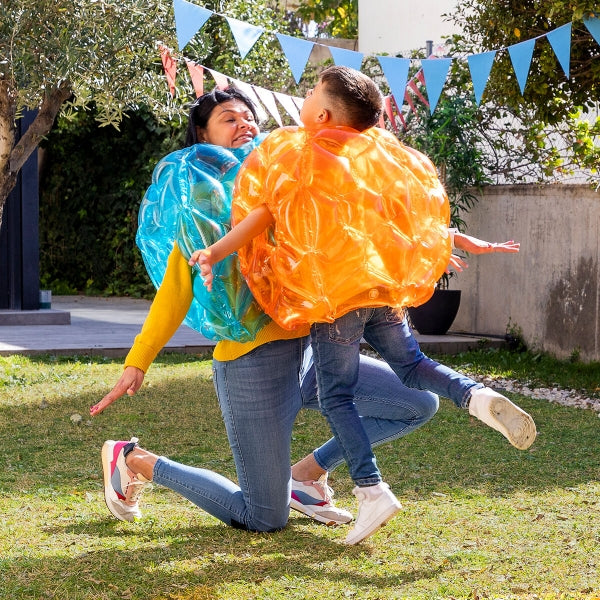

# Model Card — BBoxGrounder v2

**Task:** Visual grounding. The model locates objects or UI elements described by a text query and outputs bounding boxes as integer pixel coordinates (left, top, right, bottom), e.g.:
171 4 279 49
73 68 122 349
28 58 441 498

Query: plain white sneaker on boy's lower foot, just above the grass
344 481 402 545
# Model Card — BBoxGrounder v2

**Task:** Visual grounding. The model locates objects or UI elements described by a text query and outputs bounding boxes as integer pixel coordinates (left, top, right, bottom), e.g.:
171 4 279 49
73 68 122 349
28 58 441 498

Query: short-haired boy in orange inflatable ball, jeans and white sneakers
190 67 535 544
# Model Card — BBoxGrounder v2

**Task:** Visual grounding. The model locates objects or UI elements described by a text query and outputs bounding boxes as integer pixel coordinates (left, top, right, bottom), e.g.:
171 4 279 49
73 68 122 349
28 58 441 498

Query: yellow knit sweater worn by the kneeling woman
125 245 309 373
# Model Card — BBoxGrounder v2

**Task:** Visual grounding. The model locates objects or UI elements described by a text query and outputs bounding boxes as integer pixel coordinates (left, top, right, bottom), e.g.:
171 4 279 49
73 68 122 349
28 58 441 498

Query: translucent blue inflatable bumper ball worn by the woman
136 136 269 342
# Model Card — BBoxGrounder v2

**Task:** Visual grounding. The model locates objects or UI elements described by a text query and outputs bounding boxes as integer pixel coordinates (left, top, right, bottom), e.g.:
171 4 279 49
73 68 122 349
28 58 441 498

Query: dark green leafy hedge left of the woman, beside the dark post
40 110 183 297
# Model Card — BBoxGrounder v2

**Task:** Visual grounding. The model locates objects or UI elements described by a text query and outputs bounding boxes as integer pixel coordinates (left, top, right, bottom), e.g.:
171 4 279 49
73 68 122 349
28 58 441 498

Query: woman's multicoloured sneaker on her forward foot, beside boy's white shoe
290 473 352 527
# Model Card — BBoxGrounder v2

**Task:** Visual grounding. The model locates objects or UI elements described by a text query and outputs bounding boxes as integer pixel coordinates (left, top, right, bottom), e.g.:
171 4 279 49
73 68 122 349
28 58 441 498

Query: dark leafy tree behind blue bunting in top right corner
447 0 600 124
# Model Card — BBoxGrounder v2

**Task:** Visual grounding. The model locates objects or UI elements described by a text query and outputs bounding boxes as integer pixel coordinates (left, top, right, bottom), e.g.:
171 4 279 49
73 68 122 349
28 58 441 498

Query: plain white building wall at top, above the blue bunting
358 0 456 56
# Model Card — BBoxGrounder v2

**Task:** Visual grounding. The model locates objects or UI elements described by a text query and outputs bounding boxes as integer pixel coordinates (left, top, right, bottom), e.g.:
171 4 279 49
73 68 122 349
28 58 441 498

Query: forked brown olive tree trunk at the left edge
0 80 72 227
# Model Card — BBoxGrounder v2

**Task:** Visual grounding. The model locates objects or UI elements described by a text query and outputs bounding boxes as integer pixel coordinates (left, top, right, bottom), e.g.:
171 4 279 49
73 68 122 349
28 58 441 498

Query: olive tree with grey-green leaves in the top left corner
0 0 175 229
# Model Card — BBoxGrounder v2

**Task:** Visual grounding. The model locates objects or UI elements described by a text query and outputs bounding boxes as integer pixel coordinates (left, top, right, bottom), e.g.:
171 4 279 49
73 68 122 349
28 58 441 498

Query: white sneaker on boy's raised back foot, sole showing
469 388 537 450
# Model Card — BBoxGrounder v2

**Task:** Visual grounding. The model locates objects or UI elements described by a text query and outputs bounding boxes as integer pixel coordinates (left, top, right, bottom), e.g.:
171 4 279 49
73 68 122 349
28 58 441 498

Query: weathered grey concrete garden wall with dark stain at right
450 184 600 361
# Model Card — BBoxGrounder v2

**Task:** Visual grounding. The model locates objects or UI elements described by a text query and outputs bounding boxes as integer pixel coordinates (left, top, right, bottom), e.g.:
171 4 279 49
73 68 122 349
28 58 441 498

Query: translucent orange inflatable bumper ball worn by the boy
232 127 451 329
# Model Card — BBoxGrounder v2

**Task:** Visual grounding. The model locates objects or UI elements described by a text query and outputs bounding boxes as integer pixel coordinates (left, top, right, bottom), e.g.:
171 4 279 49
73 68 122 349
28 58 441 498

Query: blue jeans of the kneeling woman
154 314 477 531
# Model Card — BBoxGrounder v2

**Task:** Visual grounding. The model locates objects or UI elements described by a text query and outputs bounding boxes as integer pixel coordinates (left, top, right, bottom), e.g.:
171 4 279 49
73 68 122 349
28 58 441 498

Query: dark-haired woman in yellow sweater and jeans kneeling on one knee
90 84 518 531
